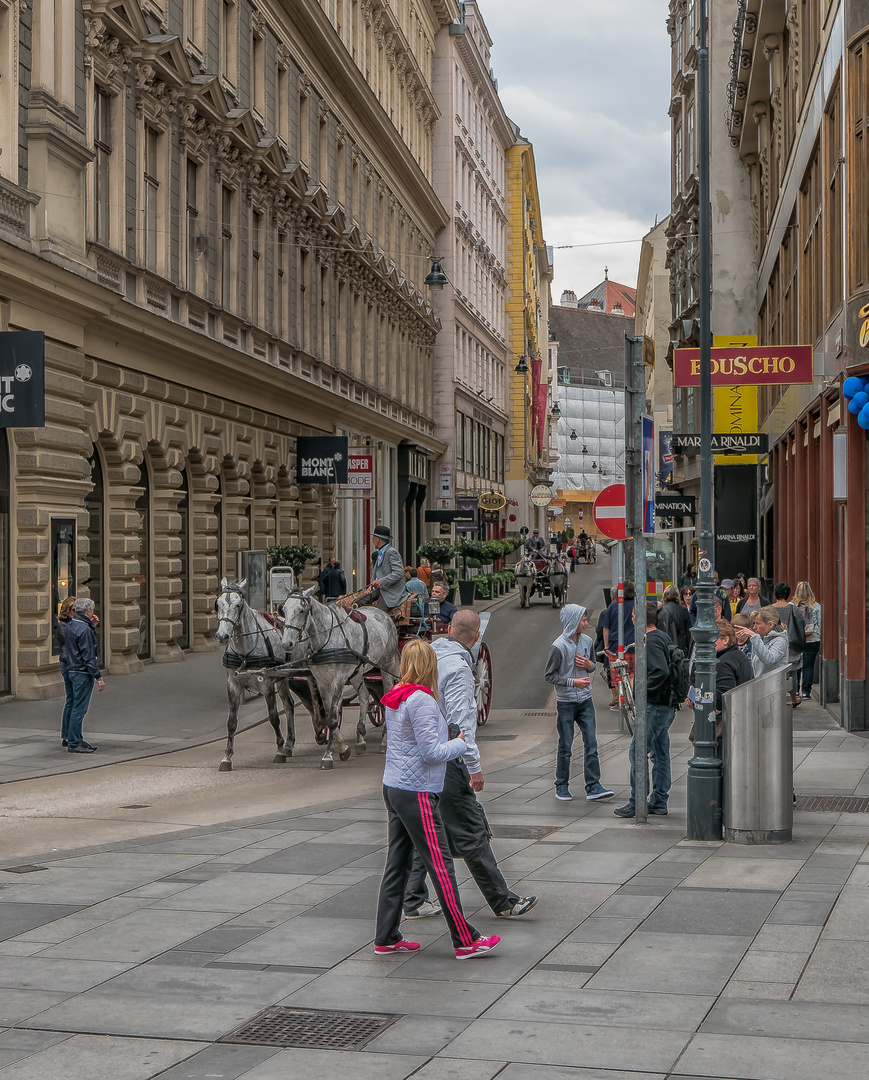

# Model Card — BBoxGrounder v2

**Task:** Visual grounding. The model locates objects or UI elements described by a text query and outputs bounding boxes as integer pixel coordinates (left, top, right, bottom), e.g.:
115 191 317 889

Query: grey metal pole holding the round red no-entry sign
625 337 649 825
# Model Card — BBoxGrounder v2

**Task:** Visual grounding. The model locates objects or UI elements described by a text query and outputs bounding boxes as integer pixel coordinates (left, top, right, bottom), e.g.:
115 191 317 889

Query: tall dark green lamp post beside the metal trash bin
688 0 723 840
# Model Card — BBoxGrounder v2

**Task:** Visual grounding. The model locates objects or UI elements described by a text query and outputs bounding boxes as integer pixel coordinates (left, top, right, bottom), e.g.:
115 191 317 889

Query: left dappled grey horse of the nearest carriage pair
215 578 296 772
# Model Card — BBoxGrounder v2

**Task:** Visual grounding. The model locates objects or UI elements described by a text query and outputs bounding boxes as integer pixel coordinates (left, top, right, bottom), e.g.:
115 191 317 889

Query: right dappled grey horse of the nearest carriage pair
281 585 399 769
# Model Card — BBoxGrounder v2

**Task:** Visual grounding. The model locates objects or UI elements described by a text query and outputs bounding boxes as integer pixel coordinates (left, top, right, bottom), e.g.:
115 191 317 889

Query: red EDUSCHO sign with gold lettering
673 345 813 387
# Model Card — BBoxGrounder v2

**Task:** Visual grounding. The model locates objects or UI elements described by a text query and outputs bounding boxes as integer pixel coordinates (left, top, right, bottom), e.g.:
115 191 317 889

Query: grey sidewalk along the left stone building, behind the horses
0 592 517 783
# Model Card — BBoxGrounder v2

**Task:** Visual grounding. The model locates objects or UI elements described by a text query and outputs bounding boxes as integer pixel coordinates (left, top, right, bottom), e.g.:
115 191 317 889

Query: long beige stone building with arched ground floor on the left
0 0 458 698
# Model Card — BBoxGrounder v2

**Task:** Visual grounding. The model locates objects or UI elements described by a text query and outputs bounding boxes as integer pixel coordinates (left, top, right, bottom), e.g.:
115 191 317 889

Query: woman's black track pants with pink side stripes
375 787 480 948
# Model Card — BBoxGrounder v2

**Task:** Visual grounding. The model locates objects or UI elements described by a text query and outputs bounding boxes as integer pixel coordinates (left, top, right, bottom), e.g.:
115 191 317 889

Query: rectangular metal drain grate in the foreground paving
217 1005 403 1050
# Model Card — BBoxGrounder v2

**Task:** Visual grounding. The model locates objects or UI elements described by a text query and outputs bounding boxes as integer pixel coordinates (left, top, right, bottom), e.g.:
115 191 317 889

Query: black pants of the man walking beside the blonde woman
405 761 520 915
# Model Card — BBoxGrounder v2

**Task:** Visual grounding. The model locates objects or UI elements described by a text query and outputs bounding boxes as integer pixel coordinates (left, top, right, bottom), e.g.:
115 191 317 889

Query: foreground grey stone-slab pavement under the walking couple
0 704 869 1080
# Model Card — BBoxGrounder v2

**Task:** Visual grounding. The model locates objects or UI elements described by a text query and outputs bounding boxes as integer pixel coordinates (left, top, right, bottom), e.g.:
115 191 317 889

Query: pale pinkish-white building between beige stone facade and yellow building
433 0 514 535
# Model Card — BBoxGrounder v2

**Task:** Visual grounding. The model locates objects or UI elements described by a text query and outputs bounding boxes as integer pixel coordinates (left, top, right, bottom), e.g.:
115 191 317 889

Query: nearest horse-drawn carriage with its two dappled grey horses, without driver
215 579 492 772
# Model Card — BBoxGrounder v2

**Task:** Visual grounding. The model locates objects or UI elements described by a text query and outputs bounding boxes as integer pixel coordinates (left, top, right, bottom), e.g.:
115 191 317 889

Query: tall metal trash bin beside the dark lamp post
722 667 793 843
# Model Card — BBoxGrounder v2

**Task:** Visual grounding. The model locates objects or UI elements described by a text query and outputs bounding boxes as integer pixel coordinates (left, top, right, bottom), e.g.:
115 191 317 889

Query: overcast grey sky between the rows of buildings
479 0 670 303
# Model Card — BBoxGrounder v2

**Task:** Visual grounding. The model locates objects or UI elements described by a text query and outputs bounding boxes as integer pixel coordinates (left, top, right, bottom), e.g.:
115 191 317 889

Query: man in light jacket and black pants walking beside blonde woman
405 608 538 919
